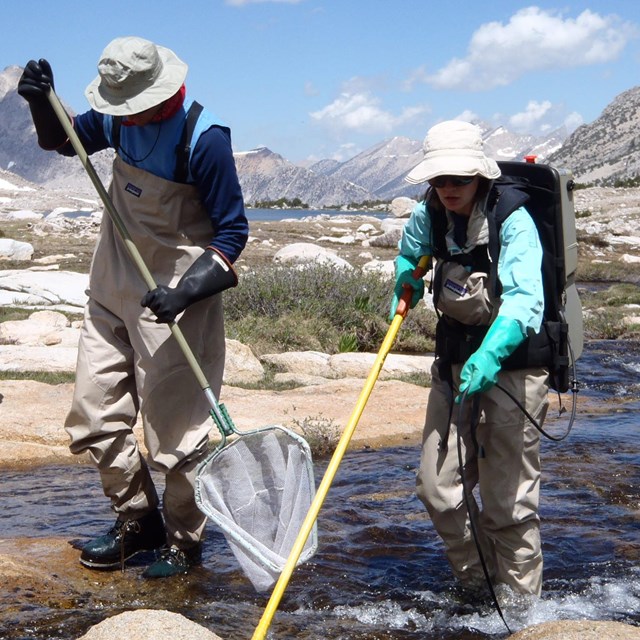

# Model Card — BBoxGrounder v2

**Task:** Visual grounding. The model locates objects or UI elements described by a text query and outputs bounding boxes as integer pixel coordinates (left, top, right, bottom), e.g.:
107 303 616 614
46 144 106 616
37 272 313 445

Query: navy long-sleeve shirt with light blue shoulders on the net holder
58 94 249 262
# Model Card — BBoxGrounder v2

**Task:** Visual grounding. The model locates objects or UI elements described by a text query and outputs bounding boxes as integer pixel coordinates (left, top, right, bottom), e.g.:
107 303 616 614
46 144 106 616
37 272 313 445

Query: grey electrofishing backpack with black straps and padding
487 161 583 393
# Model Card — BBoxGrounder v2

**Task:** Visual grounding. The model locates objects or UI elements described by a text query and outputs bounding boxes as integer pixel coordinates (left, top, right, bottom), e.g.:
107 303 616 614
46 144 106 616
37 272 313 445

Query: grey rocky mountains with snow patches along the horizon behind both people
0 65 640 208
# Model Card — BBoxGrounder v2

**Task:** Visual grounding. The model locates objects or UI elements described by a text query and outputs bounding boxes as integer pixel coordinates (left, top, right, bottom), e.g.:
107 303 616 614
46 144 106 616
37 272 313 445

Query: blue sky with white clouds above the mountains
0 0 640 163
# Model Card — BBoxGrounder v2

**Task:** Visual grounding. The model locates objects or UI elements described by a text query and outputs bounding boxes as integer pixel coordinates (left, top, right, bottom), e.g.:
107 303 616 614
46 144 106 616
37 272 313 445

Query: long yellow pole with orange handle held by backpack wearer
251 256 429 640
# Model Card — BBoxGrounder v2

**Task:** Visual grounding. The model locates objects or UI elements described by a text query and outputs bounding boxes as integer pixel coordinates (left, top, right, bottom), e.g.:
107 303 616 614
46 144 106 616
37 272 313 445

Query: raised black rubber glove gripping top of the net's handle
18 58 67 149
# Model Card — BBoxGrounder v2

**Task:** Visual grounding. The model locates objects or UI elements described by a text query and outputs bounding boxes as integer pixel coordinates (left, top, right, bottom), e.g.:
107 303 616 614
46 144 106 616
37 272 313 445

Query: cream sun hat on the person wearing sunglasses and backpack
405 120 500 184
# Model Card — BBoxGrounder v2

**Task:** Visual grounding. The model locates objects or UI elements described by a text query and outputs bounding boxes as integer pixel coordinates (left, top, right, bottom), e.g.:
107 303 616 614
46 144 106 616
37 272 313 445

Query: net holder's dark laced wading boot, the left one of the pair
80 509 167 569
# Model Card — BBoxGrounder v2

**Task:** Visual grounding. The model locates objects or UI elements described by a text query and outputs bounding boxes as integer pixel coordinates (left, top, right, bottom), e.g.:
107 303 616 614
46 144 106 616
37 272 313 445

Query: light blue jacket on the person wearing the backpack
398 201 544 336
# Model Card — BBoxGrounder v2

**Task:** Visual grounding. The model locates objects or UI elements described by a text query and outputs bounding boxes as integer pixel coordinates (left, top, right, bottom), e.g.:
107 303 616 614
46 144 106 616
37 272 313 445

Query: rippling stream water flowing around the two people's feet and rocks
0 342 640 640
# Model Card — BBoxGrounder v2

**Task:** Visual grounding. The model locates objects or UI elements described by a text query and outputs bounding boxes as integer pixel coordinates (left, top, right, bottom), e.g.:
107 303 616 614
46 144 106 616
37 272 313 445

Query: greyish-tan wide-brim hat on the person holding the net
84 36 189 116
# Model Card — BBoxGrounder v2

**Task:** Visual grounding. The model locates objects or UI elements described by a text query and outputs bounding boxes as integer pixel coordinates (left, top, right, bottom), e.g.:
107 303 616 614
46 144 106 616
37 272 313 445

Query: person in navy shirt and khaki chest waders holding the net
18 37 248 578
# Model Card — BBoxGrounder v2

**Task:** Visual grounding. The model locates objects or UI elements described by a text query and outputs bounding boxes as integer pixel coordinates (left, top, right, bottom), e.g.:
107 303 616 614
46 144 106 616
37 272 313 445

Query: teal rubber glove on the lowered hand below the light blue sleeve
455 316 526 403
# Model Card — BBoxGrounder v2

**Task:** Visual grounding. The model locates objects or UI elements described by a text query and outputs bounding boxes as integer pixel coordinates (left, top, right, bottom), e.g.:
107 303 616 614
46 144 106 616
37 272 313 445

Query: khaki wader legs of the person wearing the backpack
417 360 548 595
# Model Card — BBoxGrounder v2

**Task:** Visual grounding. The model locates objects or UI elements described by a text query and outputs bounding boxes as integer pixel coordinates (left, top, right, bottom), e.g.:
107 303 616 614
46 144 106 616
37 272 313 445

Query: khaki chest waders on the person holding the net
65 158 225 547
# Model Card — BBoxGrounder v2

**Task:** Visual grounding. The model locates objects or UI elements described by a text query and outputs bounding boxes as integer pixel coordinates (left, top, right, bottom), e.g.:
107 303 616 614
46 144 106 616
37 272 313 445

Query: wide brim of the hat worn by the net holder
84 45 189 116
